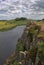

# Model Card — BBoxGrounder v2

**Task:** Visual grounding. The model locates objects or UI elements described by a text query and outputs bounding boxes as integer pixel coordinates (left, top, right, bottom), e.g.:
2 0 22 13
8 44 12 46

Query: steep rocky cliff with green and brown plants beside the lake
4 22 44 65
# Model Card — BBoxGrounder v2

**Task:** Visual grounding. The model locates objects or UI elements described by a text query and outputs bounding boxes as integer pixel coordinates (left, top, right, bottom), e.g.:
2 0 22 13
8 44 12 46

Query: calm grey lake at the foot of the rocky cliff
0 26 25 65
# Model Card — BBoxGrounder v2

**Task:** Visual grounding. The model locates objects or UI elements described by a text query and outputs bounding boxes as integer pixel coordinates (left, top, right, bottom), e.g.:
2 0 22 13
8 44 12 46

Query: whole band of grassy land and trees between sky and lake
0 18 44 31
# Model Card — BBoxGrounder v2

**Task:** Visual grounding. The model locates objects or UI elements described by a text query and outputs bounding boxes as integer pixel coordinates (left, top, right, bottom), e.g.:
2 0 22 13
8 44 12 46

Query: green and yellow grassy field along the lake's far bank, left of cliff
0 20 28 31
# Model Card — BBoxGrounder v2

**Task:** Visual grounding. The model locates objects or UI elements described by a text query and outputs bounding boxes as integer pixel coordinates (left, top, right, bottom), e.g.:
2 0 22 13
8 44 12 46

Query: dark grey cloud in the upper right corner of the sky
31 0 44 11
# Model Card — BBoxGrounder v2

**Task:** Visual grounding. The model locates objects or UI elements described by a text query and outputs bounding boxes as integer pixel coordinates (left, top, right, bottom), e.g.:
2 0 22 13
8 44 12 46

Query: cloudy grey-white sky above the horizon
0 0 44 19
